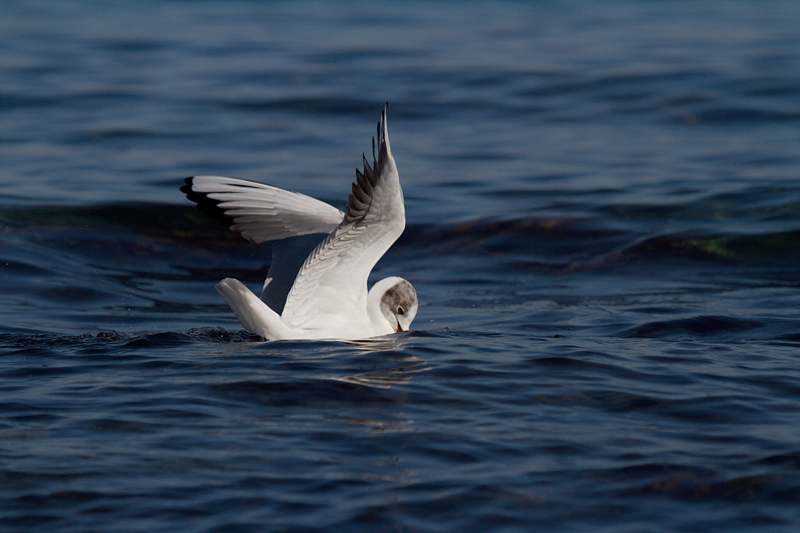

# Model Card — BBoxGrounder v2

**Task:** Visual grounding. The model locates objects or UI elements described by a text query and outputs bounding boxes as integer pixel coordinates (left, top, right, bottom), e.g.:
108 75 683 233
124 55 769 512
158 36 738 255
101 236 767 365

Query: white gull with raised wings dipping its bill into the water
181 104 418 341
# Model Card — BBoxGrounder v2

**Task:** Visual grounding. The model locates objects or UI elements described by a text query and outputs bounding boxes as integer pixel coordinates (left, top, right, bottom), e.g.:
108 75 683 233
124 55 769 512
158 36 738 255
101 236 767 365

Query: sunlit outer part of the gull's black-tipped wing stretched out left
181 176 345 244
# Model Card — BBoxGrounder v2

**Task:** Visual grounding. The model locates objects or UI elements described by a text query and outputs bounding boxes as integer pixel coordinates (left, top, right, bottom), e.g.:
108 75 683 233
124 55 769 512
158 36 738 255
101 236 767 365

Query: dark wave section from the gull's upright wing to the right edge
412 215 800 272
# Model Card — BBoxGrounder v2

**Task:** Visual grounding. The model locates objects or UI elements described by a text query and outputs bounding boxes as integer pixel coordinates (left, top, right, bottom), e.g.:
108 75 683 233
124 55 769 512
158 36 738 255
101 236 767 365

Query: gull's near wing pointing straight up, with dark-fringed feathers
282 103 406 327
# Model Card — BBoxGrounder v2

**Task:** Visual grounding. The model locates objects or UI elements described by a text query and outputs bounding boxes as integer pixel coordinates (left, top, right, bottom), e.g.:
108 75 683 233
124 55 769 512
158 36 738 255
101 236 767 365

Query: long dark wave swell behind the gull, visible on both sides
0 203 800 273
